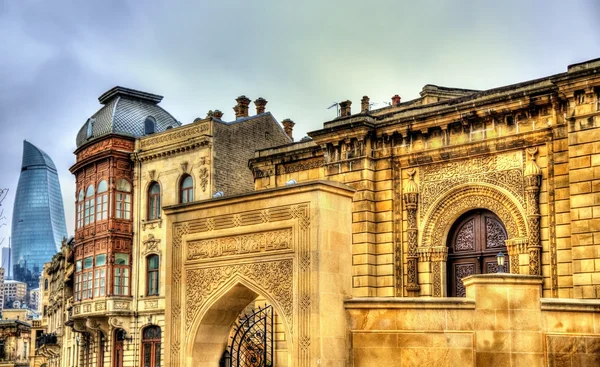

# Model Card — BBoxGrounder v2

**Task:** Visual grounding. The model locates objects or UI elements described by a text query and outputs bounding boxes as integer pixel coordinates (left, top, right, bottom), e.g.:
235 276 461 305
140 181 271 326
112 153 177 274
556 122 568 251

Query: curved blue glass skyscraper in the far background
11 141 67 288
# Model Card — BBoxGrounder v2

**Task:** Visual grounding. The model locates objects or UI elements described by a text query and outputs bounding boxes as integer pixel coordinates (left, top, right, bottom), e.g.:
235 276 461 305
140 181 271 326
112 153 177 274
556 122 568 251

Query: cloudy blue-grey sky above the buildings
0 0 600 246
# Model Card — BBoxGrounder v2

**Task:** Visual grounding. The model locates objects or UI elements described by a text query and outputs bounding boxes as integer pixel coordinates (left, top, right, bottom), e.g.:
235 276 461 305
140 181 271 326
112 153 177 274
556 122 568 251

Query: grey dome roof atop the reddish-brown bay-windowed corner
76 87 181 148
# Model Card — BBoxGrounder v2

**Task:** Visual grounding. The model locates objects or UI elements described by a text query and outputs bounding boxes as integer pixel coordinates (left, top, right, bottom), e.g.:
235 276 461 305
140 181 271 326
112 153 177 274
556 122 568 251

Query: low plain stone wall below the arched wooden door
346 274 600 367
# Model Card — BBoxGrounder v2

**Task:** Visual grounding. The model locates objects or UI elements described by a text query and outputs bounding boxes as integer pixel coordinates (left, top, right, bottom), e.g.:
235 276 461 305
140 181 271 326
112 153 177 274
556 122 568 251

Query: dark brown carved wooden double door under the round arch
448 210 508 297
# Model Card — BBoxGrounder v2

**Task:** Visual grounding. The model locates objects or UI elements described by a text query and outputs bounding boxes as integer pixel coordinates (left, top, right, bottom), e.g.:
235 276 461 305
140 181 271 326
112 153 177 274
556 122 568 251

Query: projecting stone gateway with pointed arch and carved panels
165 181 354 367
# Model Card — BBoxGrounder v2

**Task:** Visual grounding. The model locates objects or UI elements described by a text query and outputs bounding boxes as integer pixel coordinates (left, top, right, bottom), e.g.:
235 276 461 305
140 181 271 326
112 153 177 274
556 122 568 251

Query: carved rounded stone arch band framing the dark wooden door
419 183 527 247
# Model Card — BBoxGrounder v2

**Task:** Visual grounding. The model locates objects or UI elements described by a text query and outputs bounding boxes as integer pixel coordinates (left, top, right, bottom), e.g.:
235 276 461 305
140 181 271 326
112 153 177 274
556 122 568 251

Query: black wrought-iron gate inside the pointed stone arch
229 305 273 367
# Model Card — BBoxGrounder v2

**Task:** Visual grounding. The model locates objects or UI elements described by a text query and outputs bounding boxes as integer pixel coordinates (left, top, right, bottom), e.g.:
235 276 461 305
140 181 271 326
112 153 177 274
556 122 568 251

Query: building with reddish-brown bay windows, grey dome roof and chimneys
61 87 291 367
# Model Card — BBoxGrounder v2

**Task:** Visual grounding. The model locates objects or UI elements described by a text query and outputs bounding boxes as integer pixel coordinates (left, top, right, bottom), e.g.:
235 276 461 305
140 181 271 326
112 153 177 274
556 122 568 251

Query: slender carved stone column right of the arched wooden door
523 148 542 275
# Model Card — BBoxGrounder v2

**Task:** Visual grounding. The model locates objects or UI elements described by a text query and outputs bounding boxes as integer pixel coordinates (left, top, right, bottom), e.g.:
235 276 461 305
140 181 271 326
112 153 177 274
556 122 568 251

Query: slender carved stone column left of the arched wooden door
404 169 420 297
